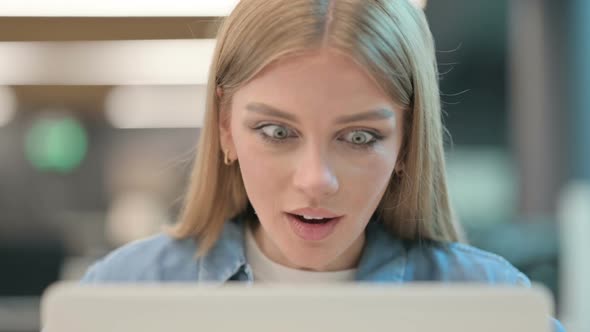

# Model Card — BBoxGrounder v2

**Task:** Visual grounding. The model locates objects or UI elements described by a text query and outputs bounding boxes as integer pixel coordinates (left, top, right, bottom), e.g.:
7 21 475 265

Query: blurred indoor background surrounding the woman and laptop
0 0 590 332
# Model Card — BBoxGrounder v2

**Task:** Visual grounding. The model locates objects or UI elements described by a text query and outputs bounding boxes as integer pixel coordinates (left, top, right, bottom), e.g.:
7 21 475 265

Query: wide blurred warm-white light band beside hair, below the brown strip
0 39 215 85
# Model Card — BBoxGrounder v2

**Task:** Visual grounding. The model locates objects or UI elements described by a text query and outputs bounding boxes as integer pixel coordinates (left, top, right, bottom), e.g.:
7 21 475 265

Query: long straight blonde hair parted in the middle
171 0 462 254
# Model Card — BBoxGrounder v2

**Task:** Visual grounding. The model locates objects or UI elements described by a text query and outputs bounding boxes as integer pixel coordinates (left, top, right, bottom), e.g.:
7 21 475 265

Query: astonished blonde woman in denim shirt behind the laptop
83 0 568 330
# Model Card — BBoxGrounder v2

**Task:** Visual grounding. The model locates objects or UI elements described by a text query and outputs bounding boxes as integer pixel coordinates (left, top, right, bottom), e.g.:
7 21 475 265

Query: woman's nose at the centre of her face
293 147 339 200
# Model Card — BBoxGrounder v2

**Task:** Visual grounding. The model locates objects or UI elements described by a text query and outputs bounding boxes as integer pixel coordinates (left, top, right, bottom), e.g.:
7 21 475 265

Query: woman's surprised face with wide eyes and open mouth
220 51 402 271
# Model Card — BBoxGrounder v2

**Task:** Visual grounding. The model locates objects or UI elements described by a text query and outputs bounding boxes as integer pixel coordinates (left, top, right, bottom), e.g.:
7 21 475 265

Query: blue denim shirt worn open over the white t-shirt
82 221 564 331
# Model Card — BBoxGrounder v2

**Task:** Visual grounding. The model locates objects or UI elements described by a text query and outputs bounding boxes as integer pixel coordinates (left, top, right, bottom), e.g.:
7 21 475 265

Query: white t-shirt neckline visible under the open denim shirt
246 227 356 283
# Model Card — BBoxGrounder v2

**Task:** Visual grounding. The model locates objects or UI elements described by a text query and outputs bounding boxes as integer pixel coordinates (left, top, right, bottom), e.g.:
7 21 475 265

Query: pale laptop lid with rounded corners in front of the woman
41 283 553 332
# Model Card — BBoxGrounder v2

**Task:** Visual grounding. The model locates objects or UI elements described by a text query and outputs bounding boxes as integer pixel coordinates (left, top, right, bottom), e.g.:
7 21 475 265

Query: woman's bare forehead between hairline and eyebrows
235 50 392 110
